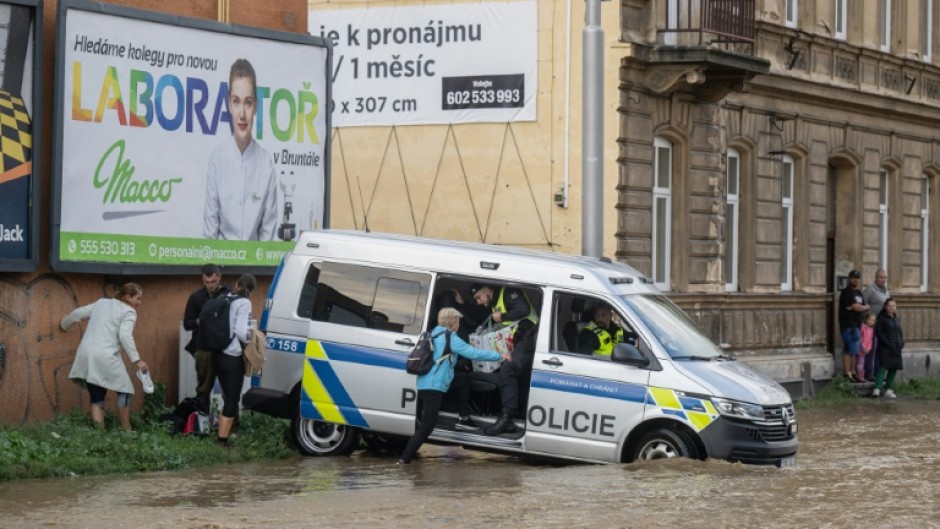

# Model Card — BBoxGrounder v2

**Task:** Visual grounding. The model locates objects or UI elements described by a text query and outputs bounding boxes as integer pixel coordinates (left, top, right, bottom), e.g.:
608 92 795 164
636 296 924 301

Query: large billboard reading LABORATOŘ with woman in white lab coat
52 1 331 273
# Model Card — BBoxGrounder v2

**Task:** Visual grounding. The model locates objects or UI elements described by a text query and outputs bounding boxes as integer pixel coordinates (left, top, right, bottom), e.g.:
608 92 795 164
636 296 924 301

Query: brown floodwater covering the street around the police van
0 398 940 529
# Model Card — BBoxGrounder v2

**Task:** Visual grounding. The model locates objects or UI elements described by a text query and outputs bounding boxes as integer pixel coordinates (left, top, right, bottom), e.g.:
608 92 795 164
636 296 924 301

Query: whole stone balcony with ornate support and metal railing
622 0 770 102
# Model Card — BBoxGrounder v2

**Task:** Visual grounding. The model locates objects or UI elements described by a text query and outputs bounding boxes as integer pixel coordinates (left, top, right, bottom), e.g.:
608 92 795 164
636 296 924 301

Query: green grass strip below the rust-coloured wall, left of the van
0 385 298 481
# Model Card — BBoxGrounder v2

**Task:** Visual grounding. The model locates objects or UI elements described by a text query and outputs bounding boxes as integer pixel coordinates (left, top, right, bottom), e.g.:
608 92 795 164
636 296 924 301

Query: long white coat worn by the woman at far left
59 298 140 393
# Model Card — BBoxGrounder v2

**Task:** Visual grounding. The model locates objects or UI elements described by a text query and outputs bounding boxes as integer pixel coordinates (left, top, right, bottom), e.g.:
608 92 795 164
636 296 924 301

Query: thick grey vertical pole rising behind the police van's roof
581 0 604 257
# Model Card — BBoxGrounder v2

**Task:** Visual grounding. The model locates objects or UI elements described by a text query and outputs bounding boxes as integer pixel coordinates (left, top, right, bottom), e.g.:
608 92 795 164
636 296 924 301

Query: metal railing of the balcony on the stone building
657 0 756 55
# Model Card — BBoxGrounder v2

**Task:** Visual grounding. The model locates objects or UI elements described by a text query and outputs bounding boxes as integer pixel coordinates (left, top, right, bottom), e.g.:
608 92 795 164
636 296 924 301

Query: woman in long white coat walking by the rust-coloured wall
59 283 147 430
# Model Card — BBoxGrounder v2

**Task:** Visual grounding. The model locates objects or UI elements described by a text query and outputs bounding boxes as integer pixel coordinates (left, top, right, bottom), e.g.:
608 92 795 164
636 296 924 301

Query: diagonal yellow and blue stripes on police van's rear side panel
297 340 369 428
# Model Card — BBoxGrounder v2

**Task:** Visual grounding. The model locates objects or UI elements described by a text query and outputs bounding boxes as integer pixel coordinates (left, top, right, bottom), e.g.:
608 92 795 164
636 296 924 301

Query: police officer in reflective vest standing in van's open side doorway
470 286 539 435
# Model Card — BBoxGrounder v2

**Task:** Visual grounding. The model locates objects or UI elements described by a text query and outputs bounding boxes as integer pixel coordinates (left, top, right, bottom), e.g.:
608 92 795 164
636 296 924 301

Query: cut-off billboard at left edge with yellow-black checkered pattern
0 0 42 272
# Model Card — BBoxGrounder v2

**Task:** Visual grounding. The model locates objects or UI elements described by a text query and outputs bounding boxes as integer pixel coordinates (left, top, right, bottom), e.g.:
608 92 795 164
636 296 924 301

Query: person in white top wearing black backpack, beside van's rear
207 274 257 446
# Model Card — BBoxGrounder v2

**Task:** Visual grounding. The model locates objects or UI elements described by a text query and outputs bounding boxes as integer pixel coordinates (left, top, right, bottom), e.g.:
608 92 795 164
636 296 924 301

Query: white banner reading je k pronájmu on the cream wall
308 1 538 127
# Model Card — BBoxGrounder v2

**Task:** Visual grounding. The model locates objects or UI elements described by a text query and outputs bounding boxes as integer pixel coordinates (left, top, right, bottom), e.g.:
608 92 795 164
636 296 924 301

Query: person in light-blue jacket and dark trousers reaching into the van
398 308 509 465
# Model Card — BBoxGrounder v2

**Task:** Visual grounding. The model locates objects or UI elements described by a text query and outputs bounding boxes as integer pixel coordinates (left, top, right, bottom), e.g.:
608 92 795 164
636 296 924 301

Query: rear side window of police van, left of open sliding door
313 263 431 334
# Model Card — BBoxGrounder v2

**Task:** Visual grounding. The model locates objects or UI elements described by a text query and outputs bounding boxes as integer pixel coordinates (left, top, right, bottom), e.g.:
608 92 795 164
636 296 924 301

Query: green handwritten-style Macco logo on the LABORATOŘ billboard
92 140 183 204
